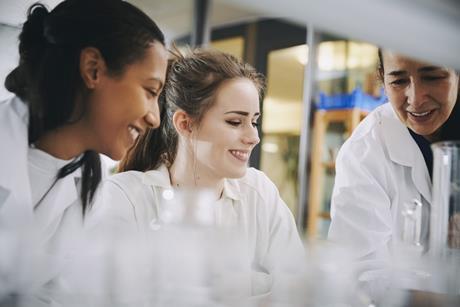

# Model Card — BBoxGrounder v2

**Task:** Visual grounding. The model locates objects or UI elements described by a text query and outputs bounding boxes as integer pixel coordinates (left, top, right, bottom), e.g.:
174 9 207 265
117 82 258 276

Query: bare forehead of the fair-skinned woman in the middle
213 78 259 113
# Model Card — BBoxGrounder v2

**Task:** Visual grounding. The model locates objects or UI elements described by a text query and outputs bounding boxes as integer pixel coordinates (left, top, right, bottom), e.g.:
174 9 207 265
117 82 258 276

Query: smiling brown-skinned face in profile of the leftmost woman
85 42 167 160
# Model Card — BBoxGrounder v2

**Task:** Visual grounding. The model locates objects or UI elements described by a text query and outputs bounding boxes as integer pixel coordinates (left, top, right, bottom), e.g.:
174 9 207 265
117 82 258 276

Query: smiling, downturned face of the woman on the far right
383 51 459 140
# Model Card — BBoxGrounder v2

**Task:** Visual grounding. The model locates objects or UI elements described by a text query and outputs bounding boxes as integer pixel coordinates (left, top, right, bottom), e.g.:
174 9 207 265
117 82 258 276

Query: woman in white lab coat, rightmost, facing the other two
329 50 460 290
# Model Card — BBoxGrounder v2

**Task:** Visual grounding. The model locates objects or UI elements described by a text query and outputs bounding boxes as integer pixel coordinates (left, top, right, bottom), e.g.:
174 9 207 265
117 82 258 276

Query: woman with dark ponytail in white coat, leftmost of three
0 0 167 242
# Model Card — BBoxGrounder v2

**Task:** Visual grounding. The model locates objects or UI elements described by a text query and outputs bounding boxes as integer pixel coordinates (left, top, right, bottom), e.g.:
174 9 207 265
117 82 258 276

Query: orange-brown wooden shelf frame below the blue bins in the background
307 108 368 238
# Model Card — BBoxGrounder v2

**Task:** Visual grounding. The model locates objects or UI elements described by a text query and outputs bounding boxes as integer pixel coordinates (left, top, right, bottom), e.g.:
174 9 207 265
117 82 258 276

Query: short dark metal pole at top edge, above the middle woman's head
190 0 211 47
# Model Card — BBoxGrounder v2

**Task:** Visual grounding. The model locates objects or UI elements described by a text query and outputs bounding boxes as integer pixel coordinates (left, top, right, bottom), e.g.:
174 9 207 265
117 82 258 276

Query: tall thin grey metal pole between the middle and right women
297 23 318 234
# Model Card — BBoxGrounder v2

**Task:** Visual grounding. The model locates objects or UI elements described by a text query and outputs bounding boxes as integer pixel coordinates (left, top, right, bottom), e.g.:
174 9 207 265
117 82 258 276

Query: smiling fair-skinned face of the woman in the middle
192 78 260 179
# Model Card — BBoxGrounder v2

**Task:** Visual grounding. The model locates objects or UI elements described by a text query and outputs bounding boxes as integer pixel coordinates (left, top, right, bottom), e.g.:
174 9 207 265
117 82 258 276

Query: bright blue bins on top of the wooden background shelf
317 88 387 111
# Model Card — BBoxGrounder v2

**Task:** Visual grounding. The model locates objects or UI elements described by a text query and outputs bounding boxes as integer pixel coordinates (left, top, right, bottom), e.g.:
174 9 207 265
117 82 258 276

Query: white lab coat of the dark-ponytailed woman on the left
0 97 82 242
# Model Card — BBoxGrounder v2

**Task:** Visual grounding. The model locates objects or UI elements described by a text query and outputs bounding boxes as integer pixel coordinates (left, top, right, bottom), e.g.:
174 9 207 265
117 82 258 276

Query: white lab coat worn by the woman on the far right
329 103 431 281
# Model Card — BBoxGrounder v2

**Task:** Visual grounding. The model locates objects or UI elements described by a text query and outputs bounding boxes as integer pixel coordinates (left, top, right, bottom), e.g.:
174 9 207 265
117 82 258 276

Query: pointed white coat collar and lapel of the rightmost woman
382 104 431 203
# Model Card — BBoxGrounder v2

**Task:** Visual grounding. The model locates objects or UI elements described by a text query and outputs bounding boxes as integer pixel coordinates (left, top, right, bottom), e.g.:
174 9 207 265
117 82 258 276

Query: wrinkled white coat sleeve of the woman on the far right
329 133 393 281
